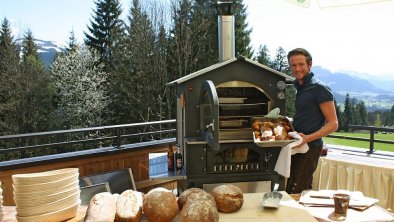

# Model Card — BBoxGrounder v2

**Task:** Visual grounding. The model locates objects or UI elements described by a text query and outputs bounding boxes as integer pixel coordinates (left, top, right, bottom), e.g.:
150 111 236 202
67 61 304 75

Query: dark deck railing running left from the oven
0 119 176 161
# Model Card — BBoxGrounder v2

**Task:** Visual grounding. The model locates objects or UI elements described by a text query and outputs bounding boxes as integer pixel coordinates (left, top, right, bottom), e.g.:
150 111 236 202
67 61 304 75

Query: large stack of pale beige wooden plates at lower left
12 168 81 222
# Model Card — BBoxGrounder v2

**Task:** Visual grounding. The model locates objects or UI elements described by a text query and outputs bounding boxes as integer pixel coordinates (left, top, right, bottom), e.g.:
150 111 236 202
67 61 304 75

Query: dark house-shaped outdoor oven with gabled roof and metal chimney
169 1 290 192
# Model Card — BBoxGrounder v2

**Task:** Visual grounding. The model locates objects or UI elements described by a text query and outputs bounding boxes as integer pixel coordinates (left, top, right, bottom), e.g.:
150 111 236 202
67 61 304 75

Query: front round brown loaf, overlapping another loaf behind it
180 199 219 222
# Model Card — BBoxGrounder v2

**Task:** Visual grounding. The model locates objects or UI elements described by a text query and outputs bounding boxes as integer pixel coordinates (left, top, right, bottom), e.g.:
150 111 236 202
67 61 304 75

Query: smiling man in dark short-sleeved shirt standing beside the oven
286 48 338 194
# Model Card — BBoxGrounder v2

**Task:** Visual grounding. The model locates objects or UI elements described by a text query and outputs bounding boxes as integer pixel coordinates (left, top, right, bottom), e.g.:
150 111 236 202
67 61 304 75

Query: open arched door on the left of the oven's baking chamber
199 80 220 150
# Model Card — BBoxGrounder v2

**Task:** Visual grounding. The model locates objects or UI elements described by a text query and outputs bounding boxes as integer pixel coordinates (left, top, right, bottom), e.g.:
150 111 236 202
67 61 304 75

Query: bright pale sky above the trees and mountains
0 0 394 80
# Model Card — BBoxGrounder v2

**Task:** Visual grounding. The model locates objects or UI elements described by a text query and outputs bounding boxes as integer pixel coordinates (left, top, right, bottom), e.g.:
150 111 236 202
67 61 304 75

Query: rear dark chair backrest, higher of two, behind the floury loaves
79 168 136 194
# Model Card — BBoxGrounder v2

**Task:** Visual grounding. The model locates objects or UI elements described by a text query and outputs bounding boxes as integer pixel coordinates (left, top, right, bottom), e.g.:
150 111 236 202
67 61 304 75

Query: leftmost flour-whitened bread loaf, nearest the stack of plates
84 192 119 222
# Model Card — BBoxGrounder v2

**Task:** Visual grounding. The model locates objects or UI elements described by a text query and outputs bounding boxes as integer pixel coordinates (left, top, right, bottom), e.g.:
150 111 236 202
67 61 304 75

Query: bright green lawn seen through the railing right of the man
324 132 394 152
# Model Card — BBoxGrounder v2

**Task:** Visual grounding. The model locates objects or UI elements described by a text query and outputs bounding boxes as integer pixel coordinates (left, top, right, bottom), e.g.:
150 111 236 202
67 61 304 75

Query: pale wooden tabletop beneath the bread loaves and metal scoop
3 192 317 222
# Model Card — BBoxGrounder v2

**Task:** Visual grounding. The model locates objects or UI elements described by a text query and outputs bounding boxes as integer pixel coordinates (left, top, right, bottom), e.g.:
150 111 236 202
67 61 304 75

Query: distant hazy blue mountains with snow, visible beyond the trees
31 39 394 109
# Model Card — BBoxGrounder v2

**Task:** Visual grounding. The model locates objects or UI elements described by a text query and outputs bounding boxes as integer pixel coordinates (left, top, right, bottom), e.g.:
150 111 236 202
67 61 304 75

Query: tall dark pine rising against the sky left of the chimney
85 0 124 73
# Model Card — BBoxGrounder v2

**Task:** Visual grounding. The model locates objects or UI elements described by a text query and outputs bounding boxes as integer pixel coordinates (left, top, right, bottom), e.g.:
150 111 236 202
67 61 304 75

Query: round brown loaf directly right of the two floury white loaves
142 187 179 222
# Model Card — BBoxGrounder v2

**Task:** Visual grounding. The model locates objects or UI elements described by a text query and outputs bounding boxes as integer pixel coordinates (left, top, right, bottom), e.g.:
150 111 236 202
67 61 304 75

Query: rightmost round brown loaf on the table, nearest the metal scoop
212 184 244 213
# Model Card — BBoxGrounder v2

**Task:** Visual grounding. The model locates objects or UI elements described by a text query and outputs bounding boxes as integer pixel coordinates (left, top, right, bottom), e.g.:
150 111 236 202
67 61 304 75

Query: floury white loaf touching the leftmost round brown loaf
115 190 143 222
